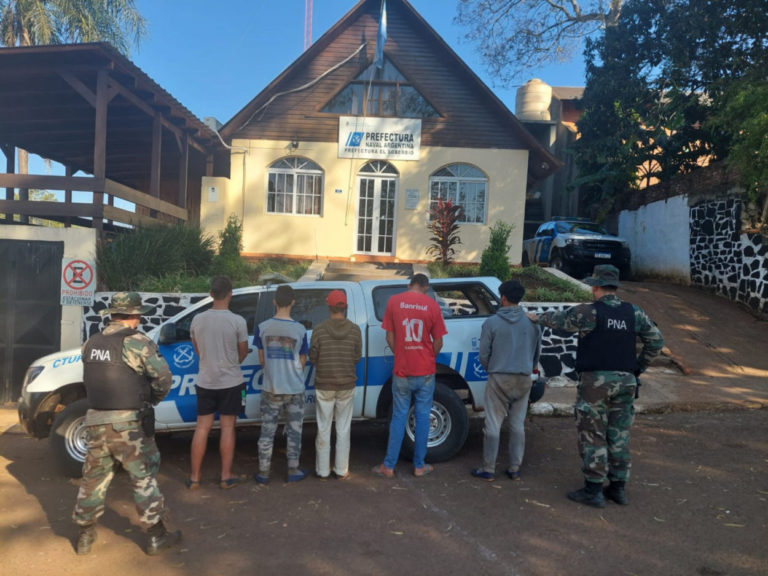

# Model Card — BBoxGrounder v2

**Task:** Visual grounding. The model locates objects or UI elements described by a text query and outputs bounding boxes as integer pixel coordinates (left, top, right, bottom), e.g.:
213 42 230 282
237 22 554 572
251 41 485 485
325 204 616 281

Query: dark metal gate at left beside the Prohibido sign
0 240 64 402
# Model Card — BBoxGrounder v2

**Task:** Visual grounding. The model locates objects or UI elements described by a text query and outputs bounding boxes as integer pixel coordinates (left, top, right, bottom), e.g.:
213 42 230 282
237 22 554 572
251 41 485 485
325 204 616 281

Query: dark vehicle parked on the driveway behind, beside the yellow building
523 218 631 278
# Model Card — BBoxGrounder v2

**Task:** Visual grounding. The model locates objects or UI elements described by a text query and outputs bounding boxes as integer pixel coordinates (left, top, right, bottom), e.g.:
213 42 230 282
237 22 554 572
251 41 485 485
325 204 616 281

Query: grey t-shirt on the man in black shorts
190 309 248 390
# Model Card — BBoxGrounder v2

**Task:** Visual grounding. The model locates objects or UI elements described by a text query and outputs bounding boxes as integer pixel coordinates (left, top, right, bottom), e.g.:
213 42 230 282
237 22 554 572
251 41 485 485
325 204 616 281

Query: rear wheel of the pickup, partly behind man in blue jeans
402 381 469 462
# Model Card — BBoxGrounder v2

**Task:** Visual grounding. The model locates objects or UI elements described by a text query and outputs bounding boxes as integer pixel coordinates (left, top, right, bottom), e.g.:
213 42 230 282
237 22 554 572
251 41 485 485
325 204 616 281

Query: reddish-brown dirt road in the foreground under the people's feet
0 408 768 576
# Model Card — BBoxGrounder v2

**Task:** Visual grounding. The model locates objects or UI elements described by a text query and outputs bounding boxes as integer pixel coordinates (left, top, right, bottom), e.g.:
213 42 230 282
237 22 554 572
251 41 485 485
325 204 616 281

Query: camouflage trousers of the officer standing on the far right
575 371 636 483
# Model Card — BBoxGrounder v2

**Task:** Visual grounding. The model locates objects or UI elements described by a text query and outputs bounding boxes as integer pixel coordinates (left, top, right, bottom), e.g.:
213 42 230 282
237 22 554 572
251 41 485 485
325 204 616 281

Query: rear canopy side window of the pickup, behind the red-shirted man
373 282 499 320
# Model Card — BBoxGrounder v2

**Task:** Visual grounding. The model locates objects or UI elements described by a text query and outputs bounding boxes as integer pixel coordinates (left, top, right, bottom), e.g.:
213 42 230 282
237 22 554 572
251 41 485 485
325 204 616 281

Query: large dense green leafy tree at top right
575 0 768 220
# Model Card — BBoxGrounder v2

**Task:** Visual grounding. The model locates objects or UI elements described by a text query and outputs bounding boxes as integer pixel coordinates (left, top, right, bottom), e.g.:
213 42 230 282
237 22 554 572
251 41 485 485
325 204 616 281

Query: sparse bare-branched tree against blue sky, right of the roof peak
456 0 623 83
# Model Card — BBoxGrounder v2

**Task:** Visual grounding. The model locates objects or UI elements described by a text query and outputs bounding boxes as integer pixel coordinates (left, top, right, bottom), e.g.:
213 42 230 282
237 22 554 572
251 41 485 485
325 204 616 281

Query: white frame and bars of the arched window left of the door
264 156 324 216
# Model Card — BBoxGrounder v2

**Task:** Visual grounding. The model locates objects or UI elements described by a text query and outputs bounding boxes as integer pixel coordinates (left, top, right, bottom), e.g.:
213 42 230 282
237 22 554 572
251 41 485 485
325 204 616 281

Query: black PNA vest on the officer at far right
576 301 637 373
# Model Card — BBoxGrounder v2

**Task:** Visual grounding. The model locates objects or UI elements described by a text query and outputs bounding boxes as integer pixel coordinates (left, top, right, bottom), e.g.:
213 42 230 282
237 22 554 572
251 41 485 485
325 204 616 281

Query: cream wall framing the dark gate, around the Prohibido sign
0 225 96 350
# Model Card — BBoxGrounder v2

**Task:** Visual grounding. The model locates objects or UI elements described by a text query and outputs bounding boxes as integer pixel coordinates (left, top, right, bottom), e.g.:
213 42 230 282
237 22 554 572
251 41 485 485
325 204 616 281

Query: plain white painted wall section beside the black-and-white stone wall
619 195 691 284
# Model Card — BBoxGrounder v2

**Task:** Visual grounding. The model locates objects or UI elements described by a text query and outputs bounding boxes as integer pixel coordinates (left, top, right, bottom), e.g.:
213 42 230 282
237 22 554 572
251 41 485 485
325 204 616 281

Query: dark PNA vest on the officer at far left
83 330 150 410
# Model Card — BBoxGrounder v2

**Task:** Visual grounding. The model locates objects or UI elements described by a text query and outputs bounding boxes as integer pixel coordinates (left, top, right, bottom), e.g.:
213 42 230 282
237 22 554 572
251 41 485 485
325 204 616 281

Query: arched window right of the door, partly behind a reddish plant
429 164 488 224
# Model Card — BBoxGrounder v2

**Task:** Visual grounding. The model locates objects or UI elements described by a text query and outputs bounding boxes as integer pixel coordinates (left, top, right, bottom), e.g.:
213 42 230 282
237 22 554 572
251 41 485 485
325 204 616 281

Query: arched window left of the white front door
267 156 323 215
